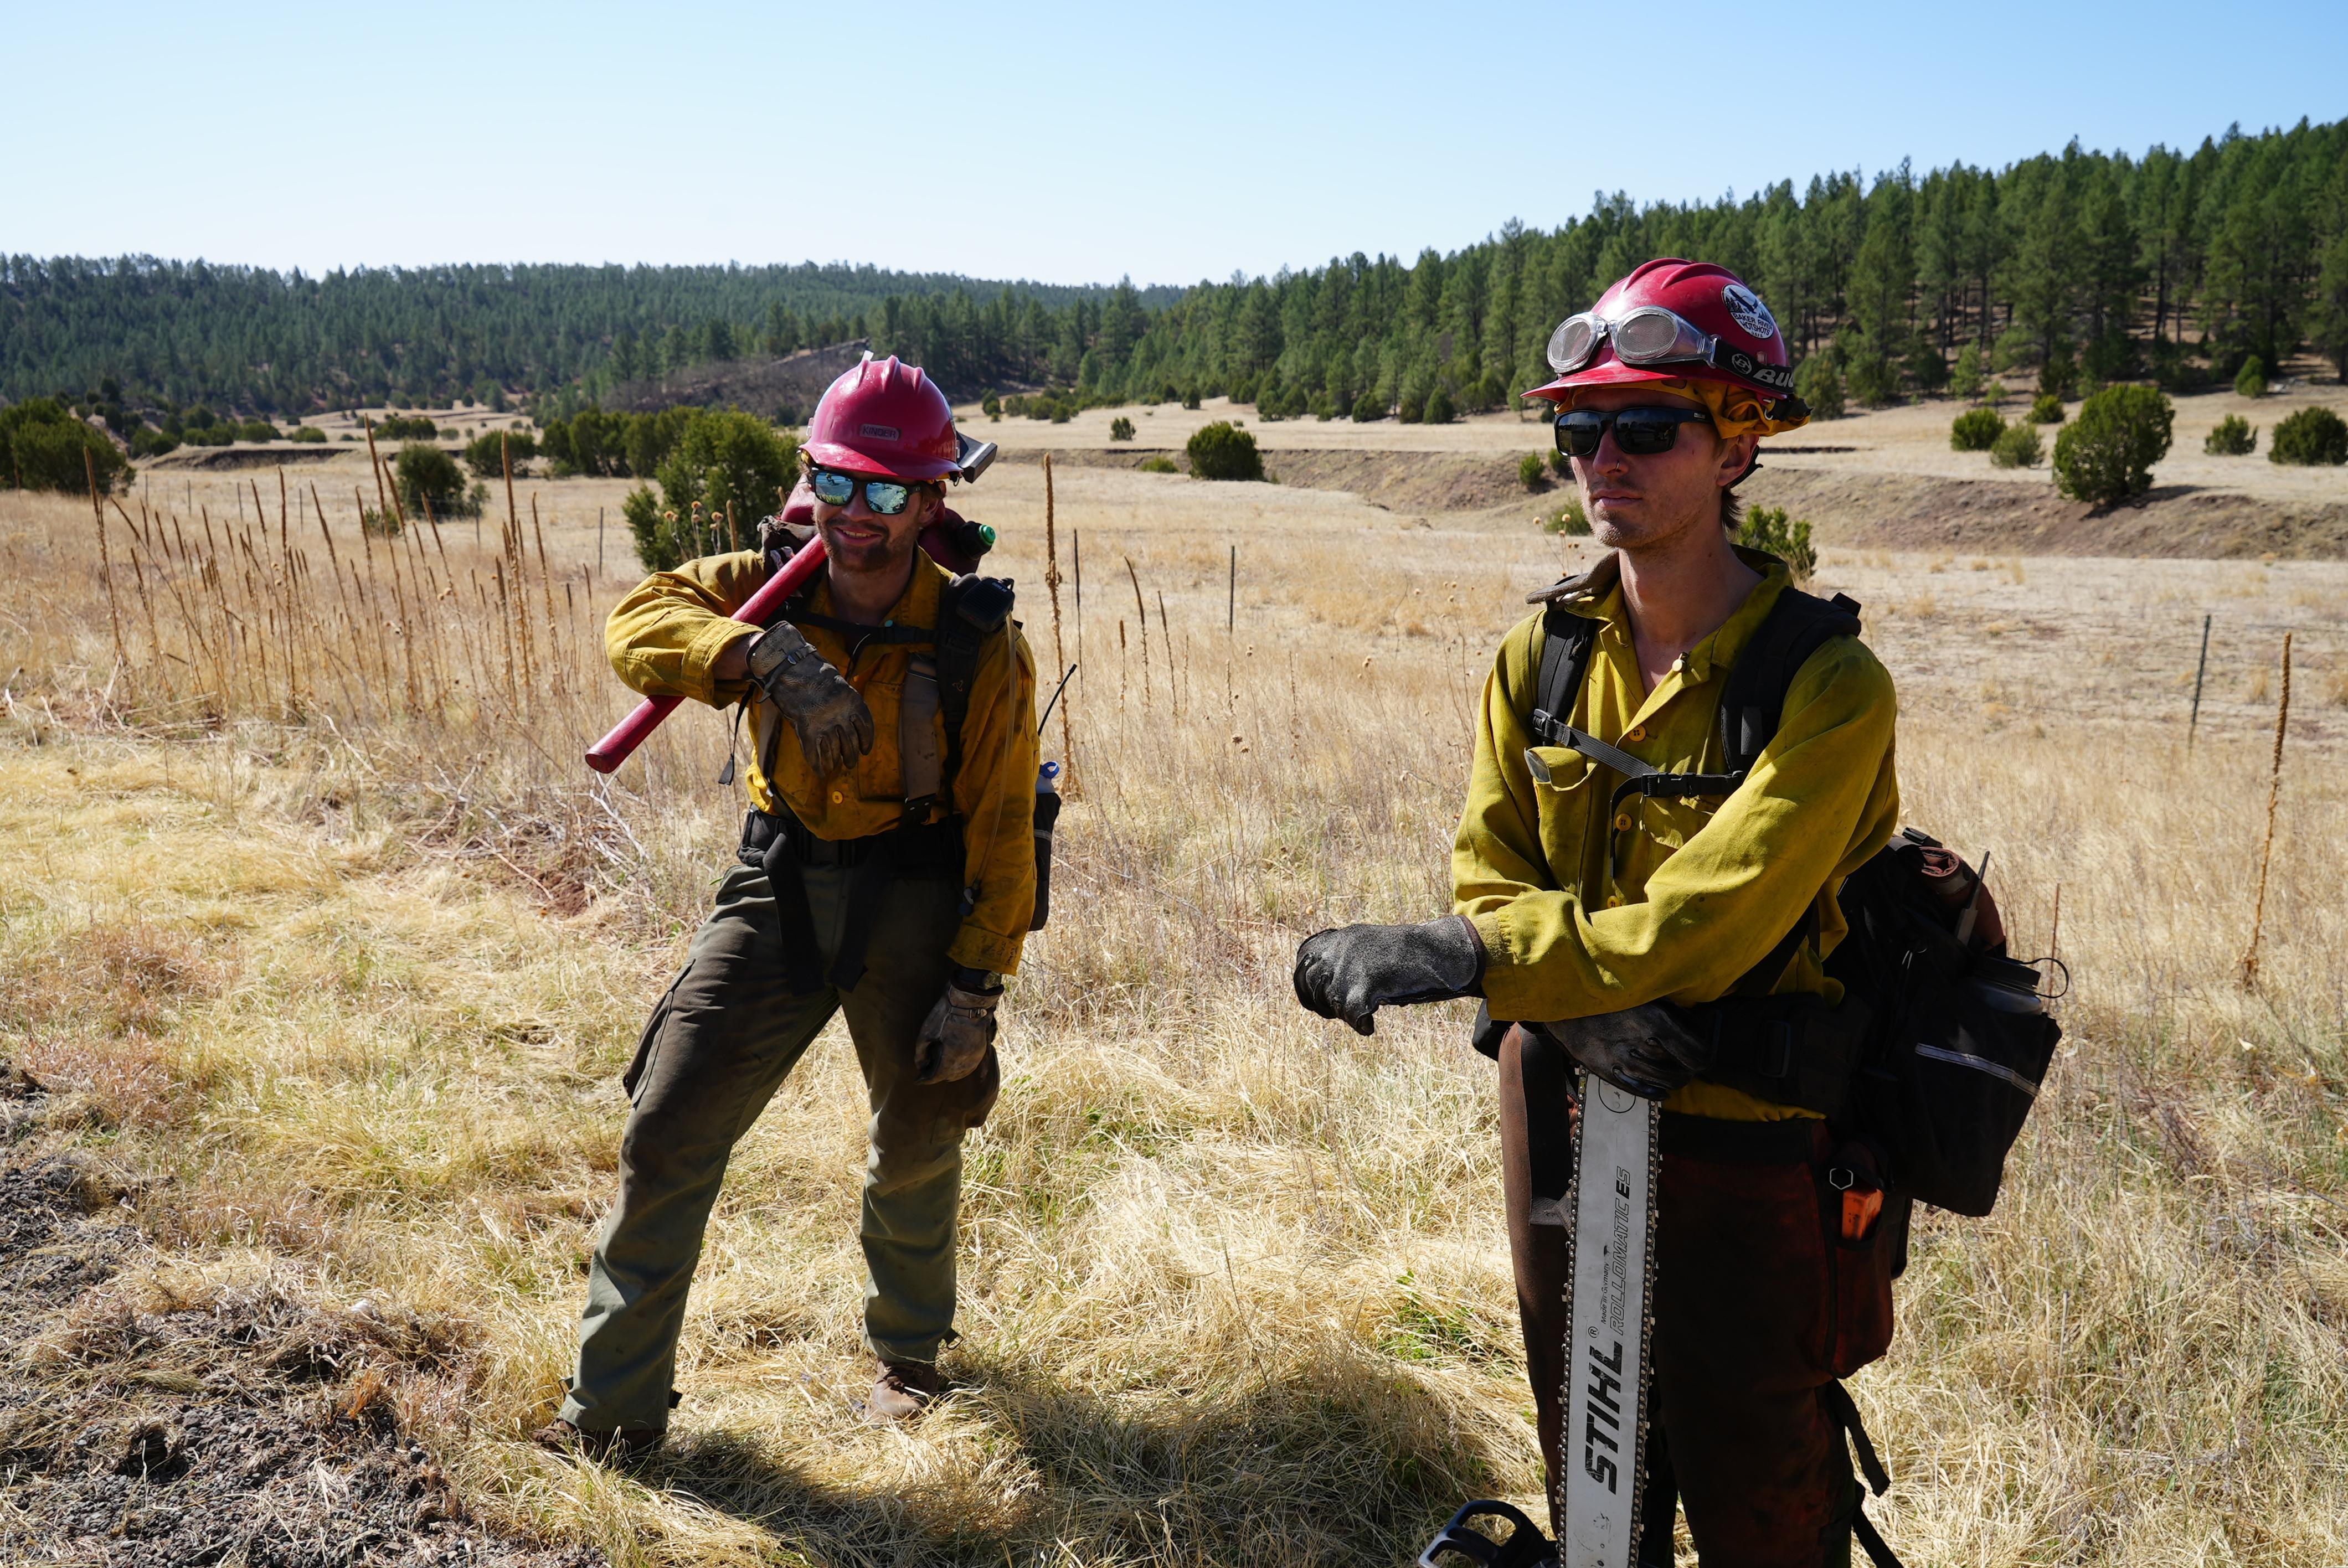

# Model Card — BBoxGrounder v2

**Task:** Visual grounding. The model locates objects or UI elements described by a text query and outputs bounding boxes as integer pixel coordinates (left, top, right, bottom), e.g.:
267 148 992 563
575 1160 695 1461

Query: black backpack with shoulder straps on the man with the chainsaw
1477 580 2062 1216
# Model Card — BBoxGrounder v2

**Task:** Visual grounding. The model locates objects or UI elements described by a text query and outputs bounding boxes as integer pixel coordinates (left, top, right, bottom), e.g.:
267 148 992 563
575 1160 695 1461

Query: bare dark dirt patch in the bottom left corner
0 1080 604 1568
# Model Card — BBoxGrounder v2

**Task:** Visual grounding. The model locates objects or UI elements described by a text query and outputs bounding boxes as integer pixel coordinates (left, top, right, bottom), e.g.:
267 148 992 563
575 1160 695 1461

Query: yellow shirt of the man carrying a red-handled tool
604 549 1036 974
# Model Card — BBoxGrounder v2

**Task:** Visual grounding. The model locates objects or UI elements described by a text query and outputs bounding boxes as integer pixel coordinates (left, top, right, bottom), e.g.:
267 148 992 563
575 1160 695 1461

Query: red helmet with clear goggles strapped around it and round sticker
1526 256 1808 413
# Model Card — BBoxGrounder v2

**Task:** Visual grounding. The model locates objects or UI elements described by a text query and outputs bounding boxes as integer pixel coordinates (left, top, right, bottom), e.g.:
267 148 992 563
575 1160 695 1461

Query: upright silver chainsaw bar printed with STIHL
1557 1072 1662 1568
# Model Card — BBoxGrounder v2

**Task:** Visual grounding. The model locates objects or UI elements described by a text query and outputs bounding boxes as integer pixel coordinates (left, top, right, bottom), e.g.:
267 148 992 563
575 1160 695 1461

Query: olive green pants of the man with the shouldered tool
561 866 1000 1432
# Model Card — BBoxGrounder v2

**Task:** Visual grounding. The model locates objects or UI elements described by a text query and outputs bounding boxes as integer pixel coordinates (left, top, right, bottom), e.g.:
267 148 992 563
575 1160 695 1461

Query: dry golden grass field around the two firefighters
0 465 2348 1568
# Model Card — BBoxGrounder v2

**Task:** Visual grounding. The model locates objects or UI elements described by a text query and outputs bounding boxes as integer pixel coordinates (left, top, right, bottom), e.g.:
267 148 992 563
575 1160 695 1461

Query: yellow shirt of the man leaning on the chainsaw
1451 551 1899 1122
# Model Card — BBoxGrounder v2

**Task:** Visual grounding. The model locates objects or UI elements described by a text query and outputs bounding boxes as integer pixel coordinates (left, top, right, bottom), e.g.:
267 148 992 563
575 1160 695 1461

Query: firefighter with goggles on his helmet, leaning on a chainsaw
1296 261 1904 1568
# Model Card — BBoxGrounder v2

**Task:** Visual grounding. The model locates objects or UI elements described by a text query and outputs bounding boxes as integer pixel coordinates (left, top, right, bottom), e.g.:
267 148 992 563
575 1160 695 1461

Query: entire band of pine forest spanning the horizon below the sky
0 122 2348 418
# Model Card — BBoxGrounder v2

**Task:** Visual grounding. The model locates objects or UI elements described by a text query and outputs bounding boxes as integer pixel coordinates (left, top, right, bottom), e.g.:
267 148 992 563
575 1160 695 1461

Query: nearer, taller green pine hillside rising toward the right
911 122 2348 413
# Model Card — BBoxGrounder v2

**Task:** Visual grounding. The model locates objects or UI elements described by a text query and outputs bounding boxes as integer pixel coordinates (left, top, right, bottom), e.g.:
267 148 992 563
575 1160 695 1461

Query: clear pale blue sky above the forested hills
0 0 2348 284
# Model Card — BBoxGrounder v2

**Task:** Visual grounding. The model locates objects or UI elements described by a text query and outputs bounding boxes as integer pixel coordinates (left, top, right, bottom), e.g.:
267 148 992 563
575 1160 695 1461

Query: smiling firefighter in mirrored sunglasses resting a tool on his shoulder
540 357 1038 1456
